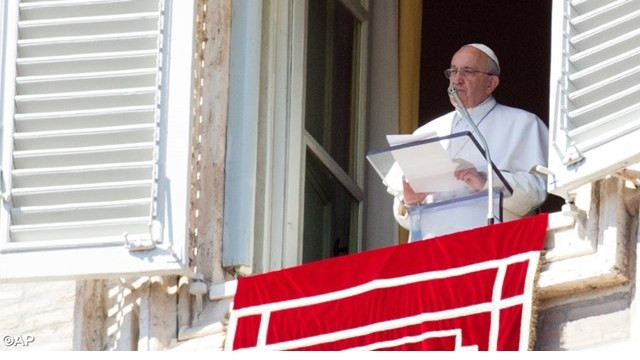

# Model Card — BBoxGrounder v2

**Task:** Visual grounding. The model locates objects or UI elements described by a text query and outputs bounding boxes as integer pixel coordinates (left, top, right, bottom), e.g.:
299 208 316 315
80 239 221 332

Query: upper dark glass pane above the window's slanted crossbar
305 1 356 173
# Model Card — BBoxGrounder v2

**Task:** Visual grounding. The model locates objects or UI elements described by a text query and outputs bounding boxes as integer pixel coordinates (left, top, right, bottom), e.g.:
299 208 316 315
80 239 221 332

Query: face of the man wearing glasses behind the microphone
449 47 499 108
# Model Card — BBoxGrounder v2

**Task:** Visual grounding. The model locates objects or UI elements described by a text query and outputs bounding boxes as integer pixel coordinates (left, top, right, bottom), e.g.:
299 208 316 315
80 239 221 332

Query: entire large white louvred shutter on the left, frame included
0 0 194 279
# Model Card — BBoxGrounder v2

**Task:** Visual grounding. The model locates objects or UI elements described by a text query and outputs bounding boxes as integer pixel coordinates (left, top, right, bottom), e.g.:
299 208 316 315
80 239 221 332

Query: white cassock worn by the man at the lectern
387 97 549 239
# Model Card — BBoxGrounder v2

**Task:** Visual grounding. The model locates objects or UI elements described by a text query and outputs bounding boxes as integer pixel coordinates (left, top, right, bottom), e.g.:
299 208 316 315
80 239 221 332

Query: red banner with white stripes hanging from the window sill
226 214 547 350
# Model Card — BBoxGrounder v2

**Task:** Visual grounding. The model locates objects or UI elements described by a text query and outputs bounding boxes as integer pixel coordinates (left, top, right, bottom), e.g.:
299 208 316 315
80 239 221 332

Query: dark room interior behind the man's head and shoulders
419 0 563 211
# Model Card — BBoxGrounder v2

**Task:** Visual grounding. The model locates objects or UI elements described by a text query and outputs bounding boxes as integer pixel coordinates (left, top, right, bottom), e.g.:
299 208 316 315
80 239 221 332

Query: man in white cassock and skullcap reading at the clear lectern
387 44 548 241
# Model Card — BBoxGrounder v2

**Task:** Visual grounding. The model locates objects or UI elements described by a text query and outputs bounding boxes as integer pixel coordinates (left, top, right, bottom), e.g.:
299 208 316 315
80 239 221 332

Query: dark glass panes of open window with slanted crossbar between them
302 0 364 262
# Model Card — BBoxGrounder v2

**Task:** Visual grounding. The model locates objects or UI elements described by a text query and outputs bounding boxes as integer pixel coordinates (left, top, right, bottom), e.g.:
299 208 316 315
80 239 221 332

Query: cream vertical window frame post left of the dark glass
254 0 307 272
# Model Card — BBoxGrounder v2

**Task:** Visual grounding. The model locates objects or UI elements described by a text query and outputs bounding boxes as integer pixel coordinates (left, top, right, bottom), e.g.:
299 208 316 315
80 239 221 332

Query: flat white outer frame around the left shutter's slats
0 0 195 282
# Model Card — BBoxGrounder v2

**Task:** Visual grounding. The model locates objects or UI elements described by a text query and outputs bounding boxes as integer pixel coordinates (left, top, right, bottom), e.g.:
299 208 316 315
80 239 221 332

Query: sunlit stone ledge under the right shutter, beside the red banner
538 177 638 300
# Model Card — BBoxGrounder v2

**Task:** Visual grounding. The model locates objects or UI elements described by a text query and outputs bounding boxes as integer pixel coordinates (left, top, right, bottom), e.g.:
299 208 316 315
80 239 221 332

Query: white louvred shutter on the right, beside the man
549 0 640 197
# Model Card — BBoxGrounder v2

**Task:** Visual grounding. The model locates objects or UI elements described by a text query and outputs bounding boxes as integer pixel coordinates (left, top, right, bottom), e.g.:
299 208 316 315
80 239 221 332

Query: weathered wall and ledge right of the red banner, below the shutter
535 177 640 350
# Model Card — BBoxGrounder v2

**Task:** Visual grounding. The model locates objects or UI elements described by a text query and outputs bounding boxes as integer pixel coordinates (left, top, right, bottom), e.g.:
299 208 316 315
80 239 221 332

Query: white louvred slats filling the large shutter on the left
1 0 193 282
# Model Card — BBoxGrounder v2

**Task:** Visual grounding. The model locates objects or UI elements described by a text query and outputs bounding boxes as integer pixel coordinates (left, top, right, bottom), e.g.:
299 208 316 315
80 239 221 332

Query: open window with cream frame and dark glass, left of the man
236 0 369 273
